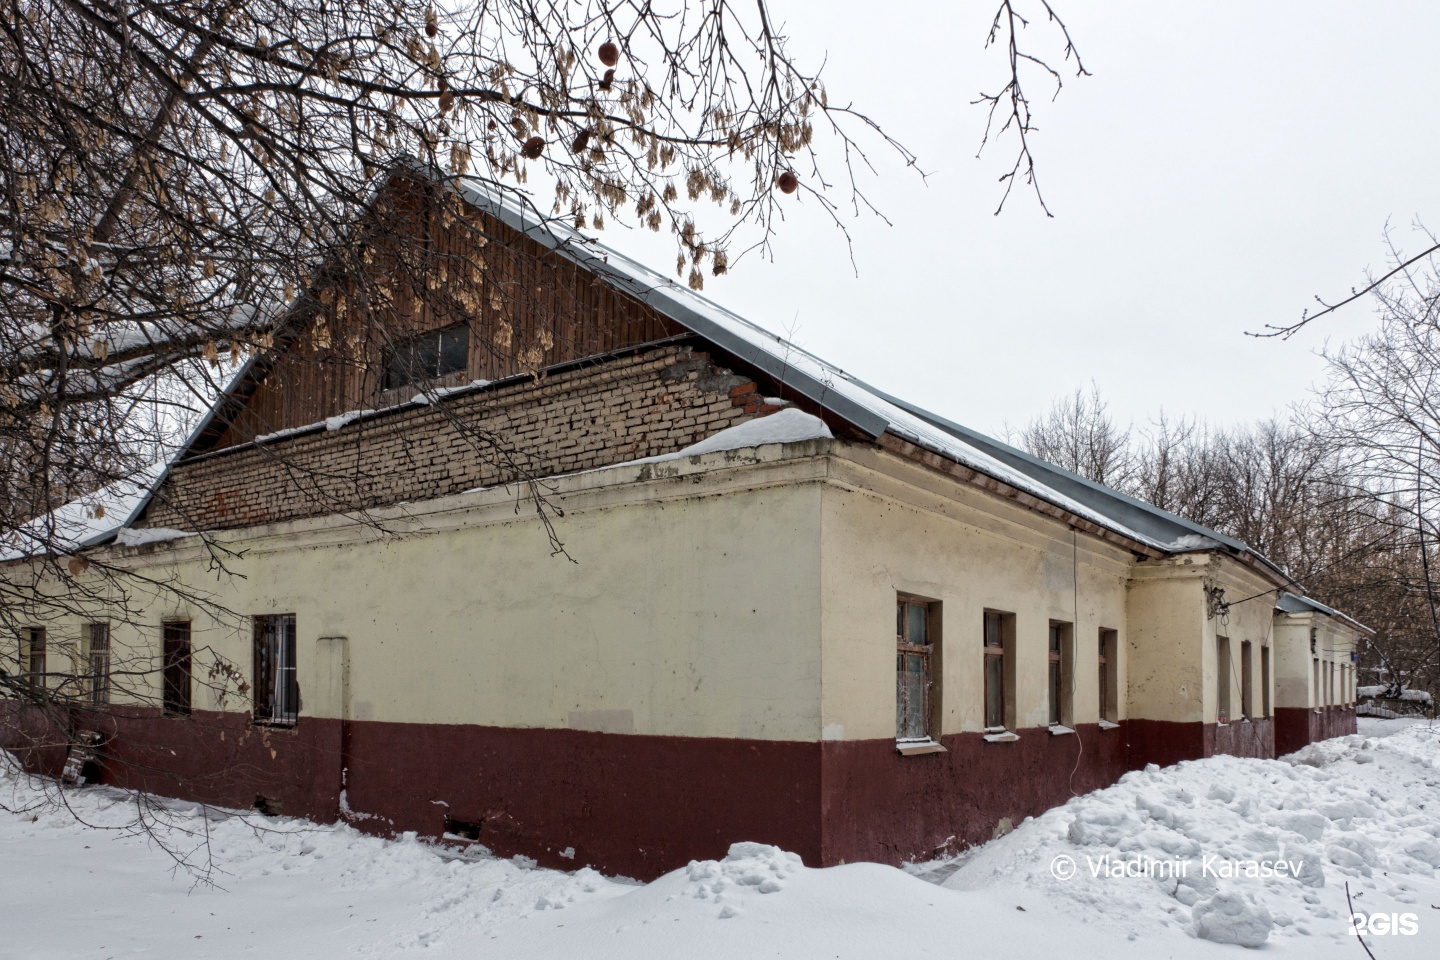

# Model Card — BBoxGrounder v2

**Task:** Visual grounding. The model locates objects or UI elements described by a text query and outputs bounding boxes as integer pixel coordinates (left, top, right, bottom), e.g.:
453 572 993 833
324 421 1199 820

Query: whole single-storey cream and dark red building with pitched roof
0 172 1362 877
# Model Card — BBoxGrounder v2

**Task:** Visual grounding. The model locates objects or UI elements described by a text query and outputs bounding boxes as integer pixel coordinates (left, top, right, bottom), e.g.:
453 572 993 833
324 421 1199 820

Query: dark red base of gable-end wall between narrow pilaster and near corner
339 723 823 879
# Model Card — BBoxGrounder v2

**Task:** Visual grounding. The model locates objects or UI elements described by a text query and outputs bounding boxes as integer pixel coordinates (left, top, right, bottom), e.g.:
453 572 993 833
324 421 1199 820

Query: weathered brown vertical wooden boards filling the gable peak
204 195 684 449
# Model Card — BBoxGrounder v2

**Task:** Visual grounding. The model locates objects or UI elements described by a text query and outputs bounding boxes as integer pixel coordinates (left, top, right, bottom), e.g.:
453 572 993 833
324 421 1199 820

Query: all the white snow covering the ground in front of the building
0 721 1440 960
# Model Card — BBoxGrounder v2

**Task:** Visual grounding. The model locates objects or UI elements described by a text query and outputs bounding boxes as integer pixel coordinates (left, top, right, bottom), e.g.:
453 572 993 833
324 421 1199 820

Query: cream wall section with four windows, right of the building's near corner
821 453 1130 740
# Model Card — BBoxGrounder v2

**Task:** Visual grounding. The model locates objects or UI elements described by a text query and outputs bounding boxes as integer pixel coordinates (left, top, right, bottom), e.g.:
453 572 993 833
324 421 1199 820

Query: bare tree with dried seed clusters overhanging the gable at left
0 0 1079 869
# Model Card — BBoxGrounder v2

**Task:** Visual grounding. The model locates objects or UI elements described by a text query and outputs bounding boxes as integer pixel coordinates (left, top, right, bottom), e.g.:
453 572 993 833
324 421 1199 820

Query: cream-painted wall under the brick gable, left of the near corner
5 455 821 740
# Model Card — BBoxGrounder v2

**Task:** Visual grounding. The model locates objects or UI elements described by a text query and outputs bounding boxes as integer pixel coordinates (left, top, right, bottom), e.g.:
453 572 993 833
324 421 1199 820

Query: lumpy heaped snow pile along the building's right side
946 725 1440 947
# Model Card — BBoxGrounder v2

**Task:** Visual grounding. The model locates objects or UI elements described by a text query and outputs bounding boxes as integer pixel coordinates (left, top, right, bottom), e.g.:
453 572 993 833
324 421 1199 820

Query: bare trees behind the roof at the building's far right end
1021 374 1440 705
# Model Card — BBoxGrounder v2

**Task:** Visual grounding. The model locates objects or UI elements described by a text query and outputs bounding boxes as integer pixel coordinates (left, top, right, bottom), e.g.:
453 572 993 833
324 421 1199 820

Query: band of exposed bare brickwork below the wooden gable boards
145 344 776 530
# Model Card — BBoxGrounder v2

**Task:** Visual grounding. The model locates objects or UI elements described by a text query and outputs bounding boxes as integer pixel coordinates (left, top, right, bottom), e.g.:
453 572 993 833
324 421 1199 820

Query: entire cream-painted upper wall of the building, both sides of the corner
7 442 1324 740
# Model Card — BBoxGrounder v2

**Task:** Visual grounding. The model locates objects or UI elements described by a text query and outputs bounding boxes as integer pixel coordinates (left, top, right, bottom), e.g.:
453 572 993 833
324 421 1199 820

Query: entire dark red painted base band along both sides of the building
0 705 1355 879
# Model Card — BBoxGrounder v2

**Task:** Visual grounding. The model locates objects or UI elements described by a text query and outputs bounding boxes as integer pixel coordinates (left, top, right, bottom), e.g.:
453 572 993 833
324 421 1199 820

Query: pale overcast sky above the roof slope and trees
603 0 1440 433
